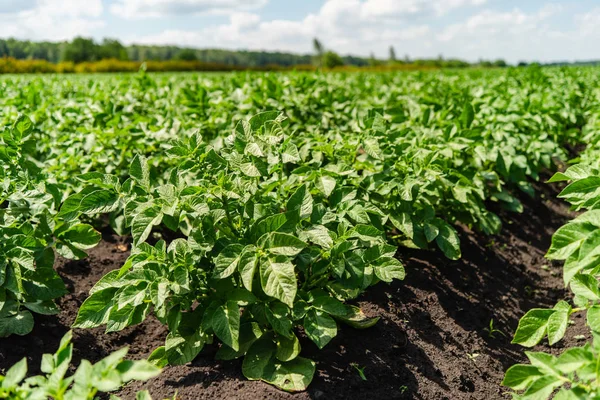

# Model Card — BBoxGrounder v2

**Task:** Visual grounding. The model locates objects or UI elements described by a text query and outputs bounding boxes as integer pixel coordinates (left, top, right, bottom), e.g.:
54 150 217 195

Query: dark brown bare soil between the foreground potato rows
0 181 586 400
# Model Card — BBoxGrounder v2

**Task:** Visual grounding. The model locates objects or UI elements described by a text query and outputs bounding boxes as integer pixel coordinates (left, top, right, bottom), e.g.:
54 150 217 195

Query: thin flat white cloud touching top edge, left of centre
110 0 268 19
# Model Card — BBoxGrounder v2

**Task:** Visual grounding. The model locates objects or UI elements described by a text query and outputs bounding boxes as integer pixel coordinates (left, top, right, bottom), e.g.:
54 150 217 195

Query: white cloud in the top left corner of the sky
0 0 104 40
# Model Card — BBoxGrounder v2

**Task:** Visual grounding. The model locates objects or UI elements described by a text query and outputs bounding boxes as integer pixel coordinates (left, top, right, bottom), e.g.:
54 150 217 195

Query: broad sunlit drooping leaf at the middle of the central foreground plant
260 256 298 307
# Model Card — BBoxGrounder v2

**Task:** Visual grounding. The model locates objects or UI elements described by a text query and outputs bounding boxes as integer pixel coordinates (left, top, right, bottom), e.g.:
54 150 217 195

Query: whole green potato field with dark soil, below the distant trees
0 66 600 400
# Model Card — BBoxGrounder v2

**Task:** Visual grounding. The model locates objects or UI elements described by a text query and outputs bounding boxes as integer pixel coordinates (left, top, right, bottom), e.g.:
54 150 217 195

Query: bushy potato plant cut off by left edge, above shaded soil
0 116 101 337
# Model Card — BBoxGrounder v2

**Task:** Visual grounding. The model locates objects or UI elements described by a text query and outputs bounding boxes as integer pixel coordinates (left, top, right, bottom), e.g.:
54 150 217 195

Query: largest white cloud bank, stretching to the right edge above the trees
128 0 600 63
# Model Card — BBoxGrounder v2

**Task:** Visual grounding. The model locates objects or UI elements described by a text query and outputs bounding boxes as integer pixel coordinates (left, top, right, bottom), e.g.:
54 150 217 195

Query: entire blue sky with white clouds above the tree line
0 0 600 63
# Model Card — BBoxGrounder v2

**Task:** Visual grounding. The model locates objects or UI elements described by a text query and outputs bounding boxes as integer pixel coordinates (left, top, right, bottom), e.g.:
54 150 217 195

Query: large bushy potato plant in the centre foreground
67 112 404 391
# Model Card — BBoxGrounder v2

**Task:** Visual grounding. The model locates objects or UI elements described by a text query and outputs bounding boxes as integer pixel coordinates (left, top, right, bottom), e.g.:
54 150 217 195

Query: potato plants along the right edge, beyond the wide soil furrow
503 104 600 400
